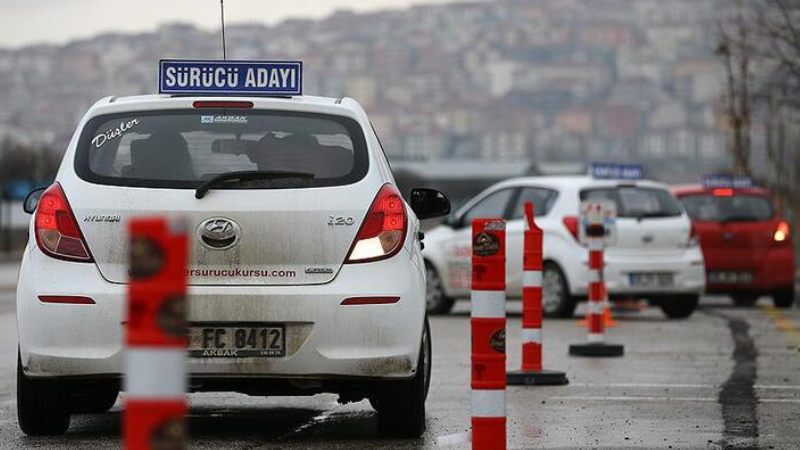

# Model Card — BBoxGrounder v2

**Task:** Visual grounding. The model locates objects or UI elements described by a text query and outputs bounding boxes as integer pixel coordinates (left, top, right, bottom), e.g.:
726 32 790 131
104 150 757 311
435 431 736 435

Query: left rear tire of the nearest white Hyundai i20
17 353 70 436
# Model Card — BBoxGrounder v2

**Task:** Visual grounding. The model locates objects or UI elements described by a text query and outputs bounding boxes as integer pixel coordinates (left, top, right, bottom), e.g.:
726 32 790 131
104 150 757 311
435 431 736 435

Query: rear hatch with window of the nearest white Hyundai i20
65 104 372 285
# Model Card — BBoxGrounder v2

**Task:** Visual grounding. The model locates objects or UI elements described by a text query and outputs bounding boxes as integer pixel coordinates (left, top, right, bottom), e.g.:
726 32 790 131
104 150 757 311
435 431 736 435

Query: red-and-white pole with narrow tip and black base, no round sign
506 202 569 386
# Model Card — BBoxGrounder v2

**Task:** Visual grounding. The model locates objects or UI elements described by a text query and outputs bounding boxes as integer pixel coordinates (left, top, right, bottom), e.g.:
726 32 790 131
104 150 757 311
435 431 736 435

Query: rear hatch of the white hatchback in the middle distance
580 185 691 257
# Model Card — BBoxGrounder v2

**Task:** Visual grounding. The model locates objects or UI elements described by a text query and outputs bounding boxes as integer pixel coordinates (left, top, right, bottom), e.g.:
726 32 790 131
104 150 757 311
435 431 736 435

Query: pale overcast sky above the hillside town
0 0 482 47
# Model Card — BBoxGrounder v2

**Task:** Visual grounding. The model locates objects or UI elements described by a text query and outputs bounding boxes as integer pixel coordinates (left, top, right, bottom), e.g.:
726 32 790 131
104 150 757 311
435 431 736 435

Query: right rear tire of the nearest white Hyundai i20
370 318 433 438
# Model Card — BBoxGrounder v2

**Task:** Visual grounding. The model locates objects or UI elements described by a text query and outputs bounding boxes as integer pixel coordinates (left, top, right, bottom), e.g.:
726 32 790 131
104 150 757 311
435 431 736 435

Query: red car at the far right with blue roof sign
673 185 795 308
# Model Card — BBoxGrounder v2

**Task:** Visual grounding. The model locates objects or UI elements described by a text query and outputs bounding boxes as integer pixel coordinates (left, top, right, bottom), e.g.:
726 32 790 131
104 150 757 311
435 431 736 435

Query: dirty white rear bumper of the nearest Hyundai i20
17 247 425 379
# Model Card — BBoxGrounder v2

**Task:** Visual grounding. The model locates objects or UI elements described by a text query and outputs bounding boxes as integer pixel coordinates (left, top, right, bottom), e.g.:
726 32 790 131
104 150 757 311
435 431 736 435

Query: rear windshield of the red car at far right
681 194 775 222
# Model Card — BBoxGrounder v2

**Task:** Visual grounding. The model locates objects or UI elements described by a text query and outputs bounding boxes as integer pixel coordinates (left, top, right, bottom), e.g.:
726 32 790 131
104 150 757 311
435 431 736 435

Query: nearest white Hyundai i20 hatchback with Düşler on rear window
17 95 450 437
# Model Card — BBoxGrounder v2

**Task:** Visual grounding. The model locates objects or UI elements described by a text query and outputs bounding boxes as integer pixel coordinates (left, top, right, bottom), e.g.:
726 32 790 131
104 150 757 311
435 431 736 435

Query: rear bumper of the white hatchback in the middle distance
570 248 705 297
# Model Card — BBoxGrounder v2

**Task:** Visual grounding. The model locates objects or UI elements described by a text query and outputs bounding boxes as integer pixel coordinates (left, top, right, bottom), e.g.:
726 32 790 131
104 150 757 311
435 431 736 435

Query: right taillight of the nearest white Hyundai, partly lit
346 184 408 263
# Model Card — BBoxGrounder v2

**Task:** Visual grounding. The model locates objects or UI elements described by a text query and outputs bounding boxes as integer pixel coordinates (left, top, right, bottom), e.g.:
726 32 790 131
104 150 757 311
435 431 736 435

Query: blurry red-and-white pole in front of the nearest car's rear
123 218 188 450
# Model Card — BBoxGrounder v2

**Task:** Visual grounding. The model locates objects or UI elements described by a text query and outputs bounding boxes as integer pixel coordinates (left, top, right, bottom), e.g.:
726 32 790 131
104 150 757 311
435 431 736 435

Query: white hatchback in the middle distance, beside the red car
423 176 705 318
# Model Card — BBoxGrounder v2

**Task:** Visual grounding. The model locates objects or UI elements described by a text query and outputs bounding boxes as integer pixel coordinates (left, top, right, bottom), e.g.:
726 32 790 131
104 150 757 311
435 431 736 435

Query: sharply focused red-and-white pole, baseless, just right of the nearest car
471 219 506 450
